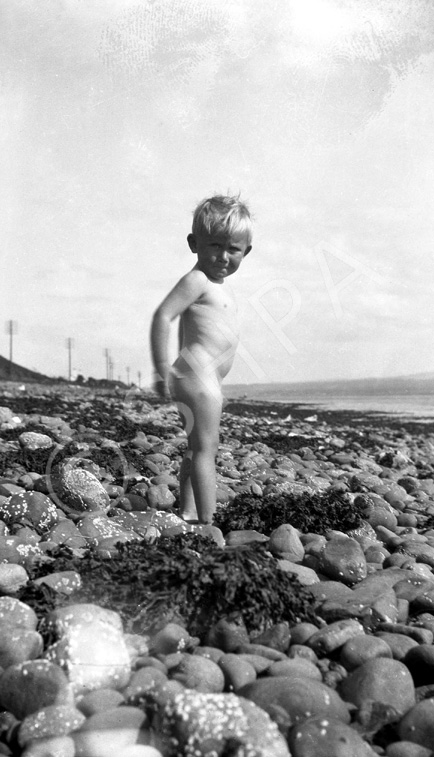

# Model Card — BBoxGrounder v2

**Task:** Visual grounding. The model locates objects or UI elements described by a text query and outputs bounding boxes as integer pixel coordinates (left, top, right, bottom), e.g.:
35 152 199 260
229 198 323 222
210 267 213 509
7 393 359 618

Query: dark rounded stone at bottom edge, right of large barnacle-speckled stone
288 716 376 757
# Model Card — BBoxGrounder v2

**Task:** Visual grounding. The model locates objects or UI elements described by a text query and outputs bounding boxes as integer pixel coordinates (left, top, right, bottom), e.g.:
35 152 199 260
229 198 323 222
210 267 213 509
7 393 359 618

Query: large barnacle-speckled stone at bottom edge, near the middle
155 689 290 757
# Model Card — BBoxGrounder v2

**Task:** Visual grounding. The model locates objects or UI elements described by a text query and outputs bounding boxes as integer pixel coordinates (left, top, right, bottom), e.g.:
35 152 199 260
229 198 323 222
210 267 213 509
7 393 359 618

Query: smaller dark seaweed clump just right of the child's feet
214 492 363 536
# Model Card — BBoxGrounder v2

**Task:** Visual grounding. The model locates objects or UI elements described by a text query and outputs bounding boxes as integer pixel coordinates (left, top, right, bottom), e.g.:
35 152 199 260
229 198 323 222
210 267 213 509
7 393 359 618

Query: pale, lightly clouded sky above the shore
0 0 434 386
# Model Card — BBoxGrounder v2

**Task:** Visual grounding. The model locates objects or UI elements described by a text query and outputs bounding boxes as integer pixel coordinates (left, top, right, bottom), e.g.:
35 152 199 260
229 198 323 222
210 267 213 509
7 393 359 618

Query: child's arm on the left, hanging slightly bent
151 269 207 399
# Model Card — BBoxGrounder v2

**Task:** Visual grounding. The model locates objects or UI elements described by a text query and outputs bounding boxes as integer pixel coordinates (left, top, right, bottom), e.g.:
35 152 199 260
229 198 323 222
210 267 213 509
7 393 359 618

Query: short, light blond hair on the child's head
192 195 252 244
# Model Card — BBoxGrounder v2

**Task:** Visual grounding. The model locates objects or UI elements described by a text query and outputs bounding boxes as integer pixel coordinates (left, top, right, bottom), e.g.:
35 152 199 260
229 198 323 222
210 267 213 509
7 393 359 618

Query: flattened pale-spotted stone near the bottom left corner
18 704 86 747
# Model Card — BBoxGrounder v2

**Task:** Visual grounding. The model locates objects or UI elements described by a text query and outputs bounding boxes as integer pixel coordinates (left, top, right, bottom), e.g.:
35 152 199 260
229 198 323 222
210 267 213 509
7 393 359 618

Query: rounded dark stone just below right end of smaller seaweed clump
318 536 367 586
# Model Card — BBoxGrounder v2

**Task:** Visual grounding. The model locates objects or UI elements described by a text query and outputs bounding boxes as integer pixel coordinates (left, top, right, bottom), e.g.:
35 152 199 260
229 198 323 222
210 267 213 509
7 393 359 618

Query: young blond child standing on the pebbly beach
151 195 252 523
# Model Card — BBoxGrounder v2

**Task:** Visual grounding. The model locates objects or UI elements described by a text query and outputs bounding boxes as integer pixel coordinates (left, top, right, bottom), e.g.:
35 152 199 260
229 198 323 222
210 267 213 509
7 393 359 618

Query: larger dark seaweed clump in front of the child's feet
19 534 317 637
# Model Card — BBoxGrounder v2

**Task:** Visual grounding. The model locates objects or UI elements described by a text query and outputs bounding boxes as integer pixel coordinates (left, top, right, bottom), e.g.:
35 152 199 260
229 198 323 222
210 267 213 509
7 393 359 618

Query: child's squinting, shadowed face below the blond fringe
187 231 252 282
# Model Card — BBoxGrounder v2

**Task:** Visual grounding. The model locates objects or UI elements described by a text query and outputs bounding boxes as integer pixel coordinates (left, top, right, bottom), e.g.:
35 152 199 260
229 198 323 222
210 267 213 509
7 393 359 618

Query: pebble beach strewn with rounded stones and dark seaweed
0 382 434 757
